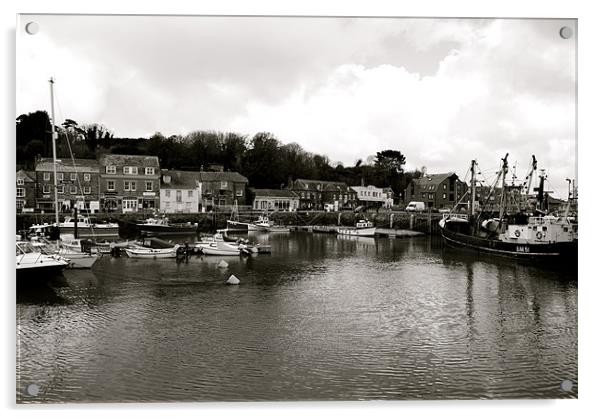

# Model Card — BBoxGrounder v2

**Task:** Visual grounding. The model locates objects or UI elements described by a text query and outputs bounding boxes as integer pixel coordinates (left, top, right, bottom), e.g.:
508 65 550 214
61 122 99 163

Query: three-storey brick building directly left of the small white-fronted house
98 154 160 213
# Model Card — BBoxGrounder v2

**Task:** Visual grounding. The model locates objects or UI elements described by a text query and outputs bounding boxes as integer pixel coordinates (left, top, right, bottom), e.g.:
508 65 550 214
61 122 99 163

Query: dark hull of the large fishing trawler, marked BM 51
441 227 577 261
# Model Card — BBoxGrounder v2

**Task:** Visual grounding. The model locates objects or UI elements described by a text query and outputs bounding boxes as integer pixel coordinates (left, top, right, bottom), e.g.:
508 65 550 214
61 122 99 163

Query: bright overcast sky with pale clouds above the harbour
17 15 576 197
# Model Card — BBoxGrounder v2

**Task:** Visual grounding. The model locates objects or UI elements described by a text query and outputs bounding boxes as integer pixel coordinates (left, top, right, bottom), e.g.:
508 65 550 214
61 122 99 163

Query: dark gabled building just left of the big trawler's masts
405 173 468 209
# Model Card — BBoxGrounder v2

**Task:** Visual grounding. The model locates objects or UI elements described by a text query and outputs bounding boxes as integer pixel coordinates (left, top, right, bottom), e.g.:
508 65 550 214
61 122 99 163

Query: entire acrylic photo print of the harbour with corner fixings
15 14 578 403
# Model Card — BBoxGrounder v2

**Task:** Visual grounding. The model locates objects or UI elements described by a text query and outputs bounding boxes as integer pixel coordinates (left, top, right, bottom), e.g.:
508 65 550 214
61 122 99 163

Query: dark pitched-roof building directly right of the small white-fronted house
199 171 249 212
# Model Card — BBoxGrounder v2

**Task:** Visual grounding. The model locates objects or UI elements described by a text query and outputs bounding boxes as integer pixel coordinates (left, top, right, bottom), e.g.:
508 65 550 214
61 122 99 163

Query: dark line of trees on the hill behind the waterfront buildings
16 111 424 197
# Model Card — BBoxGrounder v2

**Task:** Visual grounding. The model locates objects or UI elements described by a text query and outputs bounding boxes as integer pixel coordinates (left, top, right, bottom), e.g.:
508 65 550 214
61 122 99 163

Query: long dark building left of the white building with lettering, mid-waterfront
288 179 356 210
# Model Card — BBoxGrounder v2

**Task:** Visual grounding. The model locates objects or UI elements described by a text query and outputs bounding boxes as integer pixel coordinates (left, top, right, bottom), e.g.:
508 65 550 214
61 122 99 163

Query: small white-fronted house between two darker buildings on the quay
160 170 199 213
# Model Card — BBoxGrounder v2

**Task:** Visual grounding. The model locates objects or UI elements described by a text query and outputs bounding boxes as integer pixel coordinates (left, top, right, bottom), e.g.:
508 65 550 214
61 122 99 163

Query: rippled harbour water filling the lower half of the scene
16 232 578 403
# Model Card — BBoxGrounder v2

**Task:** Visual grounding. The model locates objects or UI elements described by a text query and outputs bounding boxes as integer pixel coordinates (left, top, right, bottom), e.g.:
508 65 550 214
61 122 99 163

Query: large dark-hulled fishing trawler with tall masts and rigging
439 154 577 261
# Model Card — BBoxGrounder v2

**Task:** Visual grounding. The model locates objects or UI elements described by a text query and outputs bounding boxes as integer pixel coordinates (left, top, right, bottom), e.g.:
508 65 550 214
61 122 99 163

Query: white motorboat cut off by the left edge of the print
16 242 68 279
